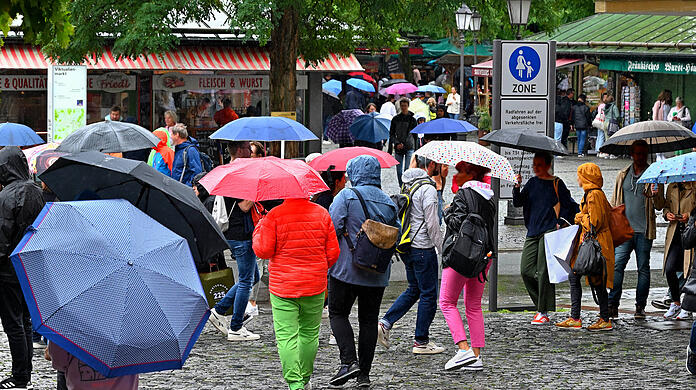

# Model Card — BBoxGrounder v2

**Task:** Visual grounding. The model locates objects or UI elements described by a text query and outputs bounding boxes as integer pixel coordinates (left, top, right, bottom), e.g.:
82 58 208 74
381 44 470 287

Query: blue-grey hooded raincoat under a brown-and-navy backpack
329 155 399 287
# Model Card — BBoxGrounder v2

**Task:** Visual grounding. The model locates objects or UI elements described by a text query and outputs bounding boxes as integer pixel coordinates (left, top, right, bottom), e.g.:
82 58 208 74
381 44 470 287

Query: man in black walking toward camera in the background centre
389 98 418 187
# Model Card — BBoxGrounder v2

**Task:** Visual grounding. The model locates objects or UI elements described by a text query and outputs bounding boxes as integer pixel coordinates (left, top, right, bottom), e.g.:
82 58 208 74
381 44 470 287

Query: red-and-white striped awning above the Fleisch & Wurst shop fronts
0 45 363 72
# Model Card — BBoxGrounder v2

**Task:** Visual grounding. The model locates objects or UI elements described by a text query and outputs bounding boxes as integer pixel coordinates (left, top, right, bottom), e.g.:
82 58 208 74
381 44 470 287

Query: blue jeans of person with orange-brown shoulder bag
609 233 652 307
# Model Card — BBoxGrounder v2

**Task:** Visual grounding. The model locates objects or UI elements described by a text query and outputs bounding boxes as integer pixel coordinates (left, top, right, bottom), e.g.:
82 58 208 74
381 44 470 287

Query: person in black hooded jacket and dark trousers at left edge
0 146 44 389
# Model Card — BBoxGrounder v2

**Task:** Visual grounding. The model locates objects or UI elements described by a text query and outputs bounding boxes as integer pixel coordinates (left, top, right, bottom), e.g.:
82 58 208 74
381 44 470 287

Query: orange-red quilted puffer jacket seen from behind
253 199 340 298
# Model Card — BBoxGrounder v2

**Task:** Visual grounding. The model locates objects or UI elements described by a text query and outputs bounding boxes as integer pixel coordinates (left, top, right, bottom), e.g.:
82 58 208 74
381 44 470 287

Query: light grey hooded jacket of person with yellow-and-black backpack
402 168 442 253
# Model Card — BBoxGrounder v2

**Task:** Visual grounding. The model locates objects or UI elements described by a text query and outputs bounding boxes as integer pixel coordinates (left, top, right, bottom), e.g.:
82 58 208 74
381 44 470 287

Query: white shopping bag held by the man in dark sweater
544 225 580 283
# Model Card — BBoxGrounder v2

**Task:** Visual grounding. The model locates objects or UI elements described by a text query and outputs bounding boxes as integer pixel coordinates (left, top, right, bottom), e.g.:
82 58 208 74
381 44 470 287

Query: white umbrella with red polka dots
416 141 515 182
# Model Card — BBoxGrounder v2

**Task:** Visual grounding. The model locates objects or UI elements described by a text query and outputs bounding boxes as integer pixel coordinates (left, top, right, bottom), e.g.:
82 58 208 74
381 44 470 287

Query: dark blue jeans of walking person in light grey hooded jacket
381 248 438 344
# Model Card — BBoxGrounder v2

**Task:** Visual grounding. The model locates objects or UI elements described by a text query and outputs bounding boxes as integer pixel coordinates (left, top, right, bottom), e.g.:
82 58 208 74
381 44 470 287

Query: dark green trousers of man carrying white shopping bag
520 234 556 313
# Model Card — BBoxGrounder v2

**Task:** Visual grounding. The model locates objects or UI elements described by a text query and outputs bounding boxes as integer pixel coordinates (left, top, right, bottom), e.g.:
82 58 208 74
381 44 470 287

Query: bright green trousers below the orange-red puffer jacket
271 293 324 390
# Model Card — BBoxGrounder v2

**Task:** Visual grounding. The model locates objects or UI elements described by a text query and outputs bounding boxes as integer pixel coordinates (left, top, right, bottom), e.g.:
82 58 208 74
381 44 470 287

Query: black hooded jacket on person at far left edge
0 146 44 283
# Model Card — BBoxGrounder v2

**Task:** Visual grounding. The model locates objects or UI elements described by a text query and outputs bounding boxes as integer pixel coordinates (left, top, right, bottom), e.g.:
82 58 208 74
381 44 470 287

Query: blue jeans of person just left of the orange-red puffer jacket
215 240 260 331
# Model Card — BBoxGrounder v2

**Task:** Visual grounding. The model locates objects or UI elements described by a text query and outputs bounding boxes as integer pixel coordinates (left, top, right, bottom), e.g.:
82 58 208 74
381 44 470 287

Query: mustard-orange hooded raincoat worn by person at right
571 163 614 288
